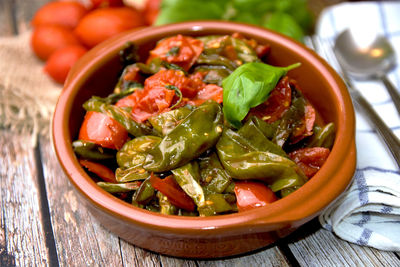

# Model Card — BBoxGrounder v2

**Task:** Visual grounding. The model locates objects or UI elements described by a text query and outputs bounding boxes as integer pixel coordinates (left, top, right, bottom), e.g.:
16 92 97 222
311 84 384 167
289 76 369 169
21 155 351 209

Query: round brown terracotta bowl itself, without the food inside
53 22 356 258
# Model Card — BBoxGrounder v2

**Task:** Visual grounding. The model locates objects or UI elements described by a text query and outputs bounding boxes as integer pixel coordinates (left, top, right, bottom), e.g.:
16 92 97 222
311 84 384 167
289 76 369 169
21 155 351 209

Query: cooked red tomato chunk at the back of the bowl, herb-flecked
147 34 204 70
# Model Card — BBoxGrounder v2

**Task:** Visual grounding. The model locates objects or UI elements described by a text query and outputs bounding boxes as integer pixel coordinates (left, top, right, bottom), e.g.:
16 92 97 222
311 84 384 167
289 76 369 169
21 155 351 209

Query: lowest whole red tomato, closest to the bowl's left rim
44 45 87 84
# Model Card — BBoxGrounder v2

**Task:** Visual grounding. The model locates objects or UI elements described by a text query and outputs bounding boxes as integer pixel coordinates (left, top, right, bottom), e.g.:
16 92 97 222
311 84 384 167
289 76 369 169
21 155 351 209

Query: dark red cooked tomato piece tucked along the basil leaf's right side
250 76 292 123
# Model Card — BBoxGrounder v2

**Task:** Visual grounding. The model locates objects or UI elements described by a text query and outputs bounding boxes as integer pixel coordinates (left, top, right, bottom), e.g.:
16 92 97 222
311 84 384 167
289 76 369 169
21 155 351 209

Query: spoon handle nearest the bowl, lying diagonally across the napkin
348 88 400 168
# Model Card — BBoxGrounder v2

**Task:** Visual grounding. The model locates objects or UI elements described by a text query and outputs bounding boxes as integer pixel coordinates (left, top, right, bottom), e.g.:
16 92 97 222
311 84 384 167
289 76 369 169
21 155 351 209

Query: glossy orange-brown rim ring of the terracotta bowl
52 21 356 235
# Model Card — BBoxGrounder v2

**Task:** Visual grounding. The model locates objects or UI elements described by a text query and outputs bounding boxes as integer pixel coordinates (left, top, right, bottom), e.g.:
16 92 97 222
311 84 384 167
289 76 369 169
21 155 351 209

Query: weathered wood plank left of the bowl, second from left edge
40 137 122 266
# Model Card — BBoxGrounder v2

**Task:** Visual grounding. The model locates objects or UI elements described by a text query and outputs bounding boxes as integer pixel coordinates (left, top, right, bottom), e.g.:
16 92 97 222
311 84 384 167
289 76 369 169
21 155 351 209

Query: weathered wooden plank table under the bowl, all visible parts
0 0 400 266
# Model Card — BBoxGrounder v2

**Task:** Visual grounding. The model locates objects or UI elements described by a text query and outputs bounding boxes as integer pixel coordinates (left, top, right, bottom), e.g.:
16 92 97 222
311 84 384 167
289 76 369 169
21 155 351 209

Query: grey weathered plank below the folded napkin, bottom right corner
288 220 400 267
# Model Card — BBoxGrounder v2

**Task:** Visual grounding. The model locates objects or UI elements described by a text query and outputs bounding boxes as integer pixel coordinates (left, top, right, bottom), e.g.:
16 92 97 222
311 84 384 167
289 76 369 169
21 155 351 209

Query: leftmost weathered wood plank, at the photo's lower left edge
0 130 49 266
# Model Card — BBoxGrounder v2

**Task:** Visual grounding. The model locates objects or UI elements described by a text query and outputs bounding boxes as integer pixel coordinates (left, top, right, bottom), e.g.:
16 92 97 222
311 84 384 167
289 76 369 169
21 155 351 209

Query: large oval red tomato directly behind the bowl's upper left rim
74 7 144 48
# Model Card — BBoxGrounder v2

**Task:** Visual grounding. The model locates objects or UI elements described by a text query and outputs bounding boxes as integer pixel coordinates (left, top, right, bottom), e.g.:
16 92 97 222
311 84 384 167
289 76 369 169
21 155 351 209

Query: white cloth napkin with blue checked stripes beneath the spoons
316 2 400 251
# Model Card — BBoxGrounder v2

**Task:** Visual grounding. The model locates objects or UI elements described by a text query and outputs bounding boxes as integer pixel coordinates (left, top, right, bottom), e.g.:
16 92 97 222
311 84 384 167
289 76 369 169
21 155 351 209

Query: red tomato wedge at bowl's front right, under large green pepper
235 181 278 212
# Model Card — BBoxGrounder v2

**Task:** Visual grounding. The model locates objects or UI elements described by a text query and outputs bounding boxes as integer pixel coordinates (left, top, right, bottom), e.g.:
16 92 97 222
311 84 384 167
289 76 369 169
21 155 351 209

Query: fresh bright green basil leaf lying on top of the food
222 62 300 128
